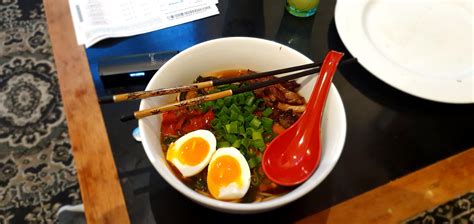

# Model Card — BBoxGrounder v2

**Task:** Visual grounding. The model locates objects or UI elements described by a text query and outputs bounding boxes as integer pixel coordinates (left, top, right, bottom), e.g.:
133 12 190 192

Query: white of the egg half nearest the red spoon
208 147 250 200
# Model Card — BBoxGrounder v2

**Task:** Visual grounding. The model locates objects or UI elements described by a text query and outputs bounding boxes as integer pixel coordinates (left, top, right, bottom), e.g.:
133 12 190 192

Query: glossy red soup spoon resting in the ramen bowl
262 51 344 186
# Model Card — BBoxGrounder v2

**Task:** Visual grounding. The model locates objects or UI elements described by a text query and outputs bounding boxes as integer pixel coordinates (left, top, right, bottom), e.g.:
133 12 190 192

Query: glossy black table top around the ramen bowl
87 0 474 223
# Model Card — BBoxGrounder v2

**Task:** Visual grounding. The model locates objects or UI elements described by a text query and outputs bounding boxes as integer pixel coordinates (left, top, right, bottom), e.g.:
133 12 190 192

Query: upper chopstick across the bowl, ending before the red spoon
99 63 321 104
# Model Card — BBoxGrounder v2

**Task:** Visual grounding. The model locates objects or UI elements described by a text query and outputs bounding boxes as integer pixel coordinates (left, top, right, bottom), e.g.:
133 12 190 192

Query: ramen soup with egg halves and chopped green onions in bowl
160 69 306 203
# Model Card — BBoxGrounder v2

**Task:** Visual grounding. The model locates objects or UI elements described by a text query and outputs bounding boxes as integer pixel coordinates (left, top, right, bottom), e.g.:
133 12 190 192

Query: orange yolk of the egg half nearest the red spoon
207 155 242 198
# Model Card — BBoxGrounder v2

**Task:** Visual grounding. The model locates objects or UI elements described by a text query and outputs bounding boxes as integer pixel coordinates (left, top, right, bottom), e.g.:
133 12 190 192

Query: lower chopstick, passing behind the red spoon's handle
120 58 357 121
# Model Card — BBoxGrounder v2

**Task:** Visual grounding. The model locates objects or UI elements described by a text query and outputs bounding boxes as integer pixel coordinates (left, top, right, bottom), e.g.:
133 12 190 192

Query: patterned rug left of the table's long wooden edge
0 0 81 223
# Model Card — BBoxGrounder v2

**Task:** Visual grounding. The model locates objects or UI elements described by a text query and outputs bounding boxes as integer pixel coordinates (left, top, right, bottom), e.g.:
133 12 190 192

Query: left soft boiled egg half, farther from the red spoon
166 130 216 177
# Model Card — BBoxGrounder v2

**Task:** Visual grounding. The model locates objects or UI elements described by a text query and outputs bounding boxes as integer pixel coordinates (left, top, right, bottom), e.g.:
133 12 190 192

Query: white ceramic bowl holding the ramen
139 37 346 213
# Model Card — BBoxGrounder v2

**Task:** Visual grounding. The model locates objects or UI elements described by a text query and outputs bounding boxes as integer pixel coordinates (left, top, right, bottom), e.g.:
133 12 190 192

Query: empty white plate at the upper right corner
335 0 474 103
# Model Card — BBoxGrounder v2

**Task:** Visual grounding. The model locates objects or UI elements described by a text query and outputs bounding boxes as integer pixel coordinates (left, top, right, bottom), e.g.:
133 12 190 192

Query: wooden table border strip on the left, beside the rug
44 0 130 224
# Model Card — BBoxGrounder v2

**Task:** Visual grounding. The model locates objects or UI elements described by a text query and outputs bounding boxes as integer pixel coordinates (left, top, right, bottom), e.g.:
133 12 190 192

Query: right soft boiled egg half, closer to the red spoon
207 147 250 200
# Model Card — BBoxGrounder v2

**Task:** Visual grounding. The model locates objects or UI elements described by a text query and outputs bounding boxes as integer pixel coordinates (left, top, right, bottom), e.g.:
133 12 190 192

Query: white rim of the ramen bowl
138 37 347 213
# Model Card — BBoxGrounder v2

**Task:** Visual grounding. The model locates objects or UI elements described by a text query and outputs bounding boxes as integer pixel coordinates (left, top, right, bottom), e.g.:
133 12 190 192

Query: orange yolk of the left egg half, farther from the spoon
166 137 210 166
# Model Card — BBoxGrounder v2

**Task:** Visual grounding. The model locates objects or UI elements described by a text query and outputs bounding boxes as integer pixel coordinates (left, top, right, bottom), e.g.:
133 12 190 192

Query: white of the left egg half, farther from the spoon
166 130 217 177
